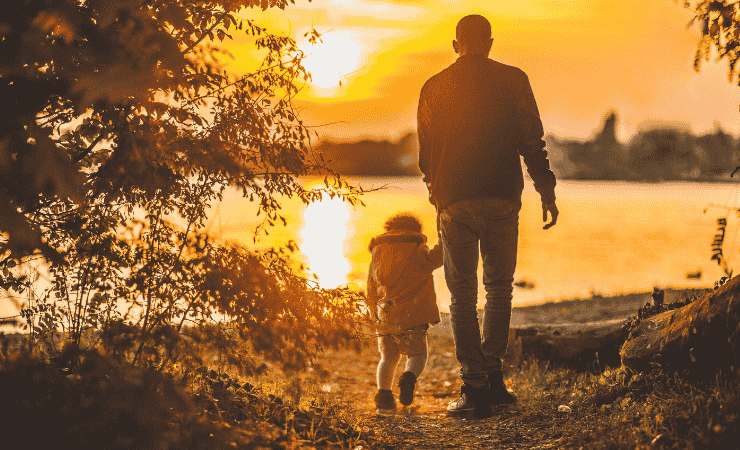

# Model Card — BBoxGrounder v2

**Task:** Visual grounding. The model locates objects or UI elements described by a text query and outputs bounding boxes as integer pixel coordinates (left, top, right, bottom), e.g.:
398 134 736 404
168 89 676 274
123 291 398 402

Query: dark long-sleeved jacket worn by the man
418 56 555 208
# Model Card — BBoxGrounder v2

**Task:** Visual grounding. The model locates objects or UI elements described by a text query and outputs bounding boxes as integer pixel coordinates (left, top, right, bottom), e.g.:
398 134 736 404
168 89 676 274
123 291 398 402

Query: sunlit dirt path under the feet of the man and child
321 336 588 449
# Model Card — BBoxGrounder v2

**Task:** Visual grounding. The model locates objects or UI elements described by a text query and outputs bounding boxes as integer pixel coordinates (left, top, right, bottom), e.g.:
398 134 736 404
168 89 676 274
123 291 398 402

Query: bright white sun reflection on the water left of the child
300 198 351 289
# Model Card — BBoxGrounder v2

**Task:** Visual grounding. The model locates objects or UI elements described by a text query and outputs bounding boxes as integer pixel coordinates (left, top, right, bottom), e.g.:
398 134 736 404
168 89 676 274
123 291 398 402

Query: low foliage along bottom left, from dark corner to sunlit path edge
0 351 382 449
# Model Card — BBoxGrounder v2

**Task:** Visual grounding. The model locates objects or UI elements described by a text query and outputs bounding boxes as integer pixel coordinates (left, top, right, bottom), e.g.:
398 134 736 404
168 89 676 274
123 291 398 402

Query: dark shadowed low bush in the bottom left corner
0 352 226 449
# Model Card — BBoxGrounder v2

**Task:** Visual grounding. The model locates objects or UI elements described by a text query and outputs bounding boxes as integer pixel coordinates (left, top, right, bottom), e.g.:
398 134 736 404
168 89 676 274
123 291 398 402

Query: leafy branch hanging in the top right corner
684 0 740 85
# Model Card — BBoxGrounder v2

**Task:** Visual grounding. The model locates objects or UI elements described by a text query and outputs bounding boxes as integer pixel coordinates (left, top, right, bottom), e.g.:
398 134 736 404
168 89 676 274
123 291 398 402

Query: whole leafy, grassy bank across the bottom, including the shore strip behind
0 291 740 450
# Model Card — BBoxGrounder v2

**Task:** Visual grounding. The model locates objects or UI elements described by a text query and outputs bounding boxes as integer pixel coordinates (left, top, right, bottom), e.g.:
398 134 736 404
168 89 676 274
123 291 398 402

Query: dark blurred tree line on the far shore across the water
319 113 740 181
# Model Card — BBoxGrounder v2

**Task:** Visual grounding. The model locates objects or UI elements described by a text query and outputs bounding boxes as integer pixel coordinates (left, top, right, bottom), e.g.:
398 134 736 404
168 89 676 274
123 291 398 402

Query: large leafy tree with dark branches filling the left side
0 0 358 370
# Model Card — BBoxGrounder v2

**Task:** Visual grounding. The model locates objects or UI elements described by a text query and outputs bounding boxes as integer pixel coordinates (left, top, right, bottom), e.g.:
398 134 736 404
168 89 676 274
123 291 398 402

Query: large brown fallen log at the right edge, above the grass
620 276 740 372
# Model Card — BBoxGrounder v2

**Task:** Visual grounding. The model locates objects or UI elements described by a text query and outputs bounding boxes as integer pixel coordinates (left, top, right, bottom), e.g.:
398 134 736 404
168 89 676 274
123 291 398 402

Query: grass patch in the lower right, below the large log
500 361 740 449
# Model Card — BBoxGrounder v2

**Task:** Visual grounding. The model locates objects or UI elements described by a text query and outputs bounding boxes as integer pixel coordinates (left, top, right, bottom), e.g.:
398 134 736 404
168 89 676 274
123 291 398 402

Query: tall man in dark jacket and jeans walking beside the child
418 15 558 417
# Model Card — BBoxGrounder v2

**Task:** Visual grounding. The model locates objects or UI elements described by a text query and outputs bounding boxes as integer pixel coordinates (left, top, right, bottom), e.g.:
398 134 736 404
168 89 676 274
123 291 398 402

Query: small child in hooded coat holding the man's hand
367 213 442 414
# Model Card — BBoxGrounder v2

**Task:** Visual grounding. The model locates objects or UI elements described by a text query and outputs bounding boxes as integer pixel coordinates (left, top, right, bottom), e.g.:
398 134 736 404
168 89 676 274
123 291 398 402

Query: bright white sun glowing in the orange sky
301 31 362 91
